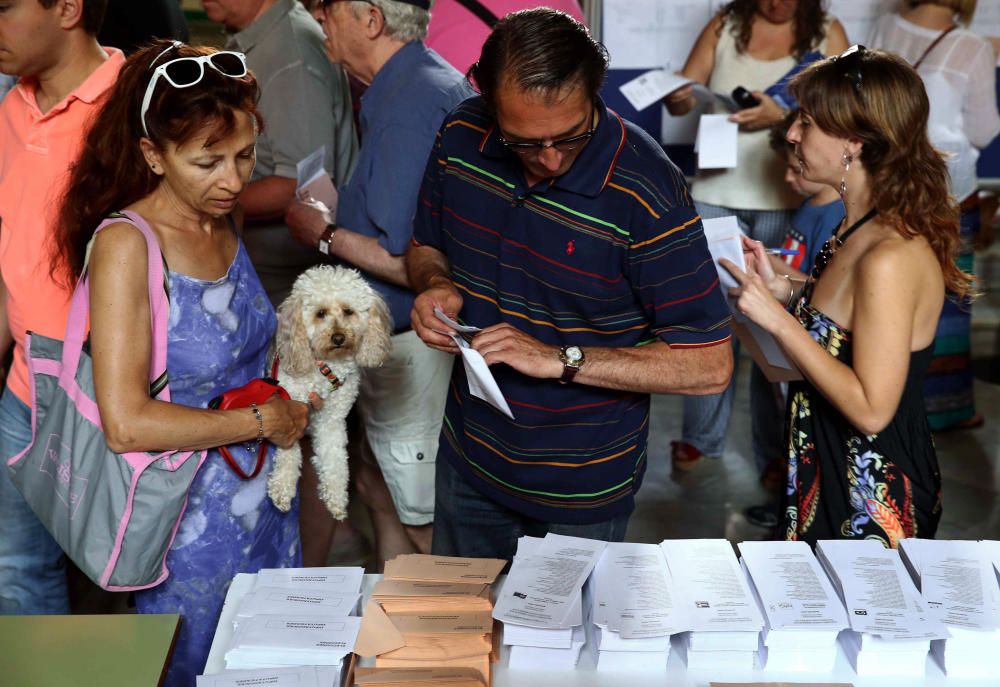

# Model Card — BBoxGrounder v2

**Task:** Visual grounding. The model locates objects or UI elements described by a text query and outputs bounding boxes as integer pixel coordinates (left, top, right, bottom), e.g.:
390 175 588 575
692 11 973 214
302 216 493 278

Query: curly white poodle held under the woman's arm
267 265 392 520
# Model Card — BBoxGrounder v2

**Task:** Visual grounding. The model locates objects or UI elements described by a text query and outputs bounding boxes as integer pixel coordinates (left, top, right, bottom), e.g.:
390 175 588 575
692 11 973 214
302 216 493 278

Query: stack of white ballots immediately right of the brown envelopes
493 534 607 670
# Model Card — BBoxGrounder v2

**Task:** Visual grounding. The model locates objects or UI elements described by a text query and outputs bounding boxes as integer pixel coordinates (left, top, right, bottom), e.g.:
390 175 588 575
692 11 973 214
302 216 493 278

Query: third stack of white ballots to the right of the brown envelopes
660 539 764 672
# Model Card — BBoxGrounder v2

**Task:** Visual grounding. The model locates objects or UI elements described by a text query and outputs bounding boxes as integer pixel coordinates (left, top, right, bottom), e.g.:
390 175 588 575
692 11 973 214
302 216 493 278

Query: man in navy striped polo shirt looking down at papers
406 8 732 558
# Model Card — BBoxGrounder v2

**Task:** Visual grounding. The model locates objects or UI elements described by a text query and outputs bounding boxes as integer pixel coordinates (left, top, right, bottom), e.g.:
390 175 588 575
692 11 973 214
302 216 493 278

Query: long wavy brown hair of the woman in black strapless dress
791 45 972 297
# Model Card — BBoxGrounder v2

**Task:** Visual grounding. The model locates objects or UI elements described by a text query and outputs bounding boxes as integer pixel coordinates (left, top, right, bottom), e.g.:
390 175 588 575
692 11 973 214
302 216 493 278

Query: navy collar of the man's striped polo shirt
479 96 625 198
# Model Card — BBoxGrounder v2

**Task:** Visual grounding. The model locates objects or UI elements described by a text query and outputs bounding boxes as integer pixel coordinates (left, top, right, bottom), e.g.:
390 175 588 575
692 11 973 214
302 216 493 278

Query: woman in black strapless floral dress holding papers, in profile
723 46 971 547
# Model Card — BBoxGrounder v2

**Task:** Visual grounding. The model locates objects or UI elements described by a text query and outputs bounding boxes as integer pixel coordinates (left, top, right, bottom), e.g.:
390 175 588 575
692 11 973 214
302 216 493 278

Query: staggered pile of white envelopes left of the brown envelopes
222 568 364 685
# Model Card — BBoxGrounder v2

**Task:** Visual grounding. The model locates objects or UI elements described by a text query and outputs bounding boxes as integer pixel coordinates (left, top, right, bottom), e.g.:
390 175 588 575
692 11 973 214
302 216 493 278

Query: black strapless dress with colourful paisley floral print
783 280 941 548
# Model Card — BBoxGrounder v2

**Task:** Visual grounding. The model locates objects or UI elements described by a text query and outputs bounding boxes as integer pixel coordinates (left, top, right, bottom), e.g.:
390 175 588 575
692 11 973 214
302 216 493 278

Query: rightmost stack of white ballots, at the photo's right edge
899 539 1000 680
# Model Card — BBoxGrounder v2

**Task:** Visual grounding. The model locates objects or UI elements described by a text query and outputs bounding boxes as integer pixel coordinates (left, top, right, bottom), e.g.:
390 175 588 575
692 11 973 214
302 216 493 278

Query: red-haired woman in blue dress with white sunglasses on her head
53 41 308 685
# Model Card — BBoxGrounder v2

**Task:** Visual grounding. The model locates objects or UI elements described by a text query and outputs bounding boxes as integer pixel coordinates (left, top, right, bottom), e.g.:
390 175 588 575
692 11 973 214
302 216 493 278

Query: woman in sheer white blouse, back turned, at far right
868 0 1000 431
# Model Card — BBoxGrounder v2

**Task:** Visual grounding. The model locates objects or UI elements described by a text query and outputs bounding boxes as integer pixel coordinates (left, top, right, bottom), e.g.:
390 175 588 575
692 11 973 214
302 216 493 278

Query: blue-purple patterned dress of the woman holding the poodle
135 232 302 687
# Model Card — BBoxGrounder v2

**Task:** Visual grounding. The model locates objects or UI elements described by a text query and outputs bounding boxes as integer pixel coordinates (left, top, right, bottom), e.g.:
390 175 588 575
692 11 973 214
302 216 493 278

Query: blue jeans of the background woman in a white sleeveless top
681 203 794 471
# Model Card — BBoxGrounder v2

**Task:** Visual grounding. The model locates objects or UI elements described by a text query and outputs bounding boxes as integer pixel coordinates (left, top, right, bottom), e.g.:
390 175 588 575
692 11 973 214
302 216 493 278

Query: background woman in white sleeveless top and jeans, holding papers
666 0 848 490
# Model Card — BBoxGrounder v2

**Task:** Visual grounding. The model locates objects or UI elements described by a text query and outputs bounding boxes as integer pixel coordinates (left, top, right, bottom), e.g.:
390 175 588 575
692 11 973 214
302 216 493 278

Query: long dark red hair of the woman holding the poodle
51 40 262 287
